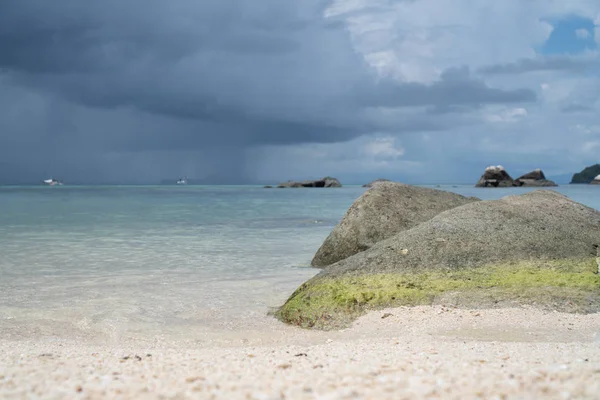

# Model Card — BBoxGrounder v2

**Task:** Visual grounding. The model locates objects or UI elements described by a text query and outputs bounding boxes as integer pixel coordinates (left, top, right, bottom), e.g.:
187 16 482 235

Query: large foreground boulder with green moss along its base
277 190 600 328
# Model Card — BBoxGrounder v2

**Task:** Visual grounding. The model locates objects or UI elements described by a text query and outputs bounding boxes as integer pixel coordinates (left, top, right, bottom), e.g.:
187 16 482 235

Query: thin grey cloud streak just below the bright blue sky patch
479 54 600 75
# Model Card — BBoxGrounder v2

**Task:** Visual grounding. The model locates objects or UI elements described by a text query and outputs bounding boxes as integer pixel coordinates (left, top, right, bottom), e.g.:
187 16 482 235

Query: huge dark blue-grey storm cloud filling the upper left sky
0 0 535 183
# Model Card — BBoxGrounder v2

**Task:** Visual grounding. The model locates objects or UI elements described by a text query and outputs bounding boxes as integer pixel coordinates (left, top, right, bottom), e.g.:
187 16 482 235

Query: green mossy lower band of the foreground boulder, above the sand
276 258 600 329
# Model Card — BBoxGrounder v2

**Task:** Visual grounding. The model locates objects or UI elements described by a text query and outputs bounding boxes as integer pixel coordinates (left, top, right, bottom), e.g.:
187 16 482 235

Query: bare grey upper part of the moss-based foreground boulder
321 190 600 276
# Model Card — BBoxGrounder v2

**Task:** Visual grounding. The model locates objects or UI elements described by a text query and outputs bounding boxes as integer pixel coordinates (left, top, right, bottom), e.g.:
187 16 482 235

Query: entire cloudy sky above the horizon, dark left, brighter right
0 0 600 183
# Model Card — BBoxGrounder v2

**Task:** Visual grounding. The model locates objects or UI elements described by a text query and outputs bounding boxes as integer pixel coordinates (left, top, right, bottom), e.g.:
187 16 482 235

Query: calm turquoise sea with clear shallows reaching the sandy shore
0 185 600 342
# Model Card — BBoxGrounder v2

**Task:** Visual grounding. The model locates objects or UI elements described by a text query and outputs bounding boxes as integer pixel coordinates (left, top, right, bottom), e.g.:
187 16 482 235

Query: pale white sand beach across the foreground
0 306 600 399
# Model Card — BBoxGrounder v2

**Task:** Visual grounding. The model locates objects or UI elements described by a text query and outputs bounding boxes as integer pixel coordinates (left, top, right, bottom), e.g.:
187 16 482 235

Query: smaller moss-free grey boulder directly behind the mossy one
312 182 479 267
